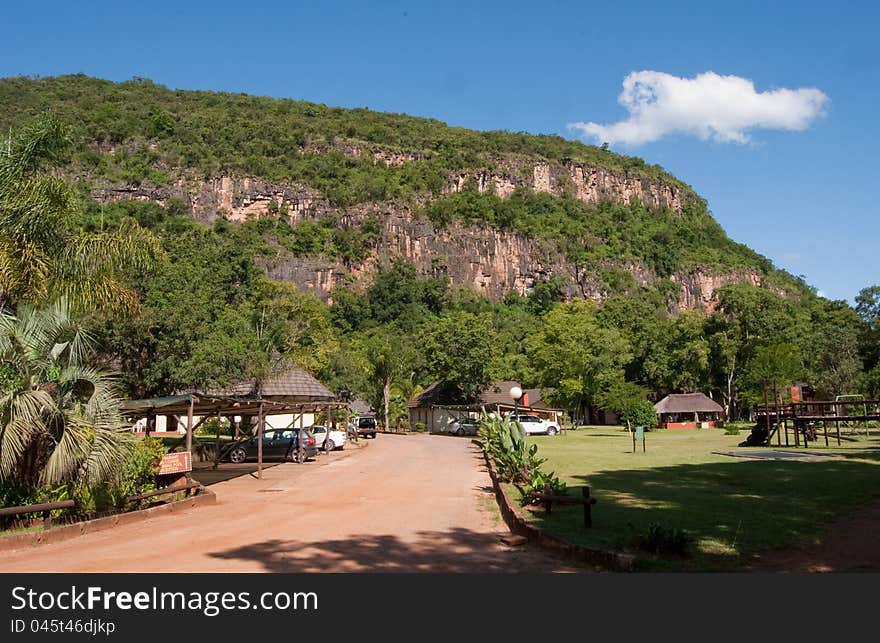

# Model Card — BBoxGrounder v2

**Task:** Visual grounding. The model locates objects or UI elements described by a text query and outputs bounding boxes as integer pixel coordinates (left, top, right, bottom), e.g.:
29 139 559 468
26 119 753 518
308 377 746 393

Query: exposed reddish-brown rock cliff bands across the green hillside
93 162 760 310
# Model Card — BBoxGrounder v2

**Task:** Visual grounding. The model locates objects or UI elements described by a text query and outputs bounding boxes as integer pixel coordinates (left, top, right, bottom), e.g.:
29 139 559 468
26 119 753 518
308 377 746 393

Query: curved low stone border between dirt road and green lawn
480 448 635 572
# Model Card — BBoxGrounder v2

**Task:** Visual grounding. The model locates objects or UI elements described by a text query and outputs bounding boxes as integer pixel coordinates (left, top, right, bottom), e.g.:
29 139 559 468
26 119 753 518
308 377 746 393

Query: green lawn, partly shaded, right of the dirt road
511 427 880 571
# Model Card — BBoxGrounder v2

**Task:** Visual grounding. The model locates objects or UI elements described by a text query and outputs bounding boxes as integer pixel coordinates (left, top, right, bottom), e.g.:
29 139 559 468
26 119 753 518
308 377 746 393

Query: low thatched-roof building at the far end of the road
408 381 562 433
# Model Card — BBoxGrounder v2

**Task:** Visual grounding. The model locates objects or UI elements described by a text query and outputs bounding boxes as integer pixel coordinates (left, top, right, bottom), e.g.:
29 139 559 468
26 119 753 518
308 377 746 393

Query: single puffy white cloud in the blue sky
568 71 829 145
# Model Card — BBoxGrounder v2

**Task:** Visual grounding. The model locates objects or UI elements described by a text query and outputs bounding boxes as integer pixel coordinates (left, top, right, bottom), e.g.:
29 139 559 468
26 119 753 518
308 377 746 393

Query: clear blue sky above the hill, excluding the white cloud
0 0 880 302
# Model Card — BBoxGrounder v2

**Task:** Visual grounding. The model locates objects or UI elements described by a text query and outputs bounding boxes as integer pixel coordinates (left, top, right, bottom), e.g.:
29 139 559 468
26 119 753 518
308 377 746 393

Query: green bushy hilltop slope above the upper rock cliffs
0 75 682 189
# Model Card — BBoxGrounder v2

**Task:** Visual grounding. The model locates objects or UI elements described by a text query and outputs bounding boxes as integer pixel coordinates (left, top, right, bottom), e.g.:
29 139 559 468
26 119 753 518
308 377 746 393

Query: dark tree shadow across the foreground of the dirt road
211 529 585 573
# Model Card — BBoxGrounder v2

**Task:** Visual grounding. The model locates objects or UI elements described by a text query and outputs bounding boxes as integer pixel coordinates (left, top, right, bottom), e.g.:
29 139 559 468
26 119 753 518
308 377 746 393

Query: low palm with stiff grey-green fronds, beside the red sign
0 299 134 488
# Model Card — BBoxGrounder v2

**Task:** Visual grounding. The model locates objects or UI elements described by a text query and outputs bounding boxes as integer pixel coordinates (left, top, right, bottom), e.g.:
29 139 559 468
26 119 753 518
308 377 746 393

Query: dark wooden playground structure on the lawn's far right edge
740 395 880 448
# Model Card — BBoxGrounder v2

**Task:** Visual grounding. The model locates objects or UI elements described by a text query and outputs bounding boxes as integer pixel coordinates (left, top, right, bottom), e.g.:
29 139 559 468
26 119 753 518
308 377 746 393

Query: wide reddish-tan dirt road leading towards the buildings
0 434 581 572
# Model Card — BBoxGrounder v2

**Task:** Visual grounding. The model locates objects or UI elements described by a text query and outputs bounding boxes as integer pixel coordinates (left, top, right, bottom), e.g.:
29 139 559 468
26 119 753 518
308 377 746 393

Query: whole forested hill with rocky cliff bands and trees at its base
0 76 868 421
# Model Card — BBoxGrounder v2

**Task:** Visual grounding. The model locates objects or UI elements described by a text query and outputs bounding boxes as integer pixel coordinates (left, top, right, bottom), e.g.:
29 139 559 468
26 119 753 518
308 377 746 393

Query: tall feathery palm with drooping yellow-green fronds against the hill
0 114 161 311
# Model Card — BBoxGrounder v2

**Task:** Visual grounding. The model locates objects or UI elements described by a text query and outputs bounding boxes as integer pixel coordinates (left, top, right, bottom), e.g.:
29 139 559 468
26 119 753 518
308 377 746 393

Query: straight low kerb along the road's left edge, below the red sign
0 487 217 551
